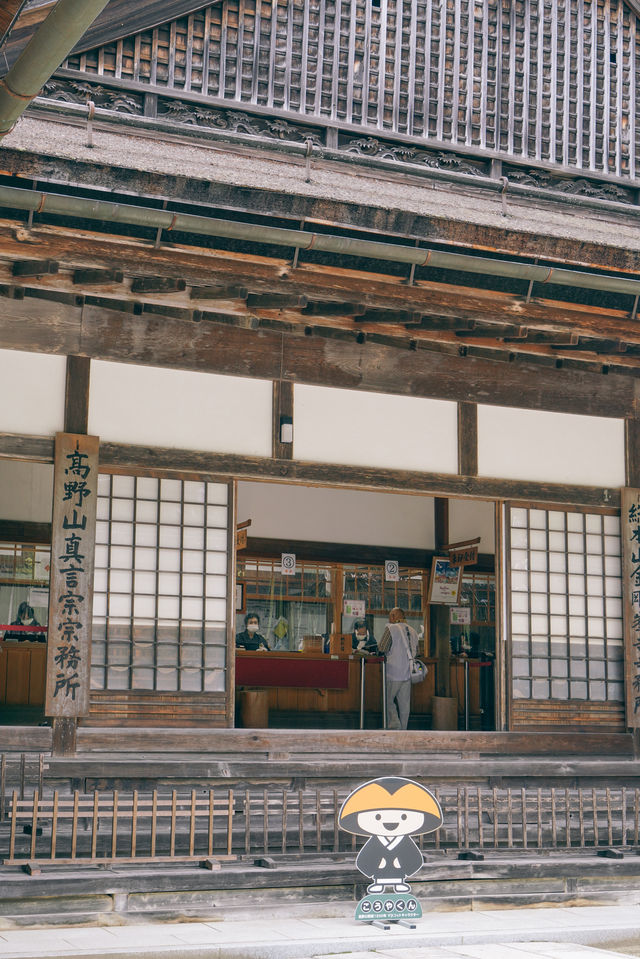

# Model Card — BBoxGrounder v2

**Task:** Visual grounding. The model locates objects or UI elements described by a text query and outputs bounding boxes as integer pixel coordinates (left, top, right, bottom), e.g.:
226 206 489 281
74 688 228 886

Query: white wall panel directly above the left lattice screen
89 360 273 456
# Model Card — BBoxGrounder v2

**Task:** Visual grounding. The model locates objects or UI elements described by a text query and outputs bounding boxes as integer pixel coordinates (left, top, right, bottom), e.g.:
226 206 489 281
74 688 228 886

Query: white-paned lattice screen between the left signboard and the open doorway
91 475 228 691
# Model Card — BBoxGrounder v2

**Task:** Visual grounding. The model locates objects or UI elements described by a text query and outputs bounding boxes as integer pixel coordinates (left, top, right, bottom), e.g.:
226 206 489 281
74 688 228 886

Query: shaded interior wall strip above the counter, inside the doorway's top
238 483 434 549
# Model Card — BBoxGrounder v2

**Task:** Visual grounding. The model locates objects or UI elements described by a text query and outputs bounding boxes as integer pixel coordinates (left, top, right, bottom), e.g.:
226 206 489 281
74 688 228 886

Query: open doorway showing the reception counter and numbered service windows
236 481 497 730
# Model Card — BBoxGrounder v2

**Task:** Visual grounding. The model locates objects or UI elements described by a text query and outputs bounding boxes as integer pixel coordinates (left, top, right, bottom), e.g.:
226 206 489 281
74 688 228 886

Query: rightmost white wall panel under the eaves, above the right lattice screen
478 405 625 487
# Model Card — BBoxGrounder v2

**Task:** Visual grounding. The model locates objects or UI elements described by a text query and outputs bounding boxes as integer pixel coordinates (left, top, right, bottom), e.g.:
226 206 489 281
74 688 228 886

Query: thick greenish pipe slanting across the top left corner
0 0 108 137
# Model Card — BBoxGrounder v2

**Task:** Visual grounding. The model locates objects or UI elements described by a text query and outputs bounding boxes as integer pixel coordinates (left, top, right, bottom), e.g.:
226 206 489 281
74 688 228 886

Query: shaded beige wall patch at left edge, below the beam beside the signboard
0 460 53 523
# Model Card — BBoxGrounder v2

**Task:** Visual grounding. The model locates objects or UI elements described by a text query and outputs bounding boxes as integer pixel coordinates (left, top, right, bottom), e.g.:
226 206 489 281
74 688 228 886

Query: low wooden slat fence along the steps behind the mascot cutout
0 786 640 863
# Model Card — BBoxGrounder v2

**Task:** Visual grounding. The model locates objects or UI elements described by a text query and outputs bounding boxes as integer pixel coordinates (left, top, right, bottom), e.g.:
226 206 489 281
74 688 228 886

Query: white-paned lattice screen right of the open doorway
509 508 624 702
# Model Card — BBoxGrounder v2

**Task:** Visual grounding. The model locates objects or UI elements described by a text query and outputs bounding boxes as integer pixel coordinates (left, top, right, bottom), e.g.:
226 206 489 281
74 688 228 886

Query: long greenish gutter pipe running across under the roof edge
0 185 640 296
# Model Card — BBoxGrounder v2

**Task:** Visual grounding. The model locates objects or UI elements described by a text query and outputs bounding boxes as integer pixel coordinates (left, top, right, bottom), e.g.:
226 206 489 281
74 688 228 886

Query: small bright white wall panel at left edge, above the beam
0 350 67 436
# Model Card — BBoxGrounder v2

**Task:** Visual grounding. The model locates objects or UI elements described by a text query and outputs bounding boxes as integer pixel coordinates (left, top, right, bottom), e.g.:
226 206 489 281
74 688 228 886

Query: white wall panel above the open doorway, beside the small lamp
293 385 458 473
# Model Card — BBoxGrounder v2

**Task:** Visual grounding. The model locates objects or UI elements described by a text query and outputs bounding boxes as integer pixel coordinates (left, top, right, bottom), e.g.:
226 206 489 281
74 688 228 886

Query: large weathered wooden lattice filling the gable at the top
58 0 640 176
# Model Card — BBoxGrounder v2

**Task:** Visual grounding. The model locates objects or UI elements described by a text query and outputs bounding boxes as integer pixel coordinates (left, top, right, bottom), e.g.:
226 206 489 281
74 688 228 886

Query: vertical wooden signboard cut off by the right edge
620 489 640 729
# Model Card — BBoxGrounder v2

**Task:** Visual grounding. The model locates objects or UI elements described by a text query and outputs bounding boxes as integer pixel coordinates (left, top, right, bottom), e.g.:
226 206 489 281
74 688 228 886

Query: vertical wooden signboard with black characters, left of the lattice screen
45 433 98 717
